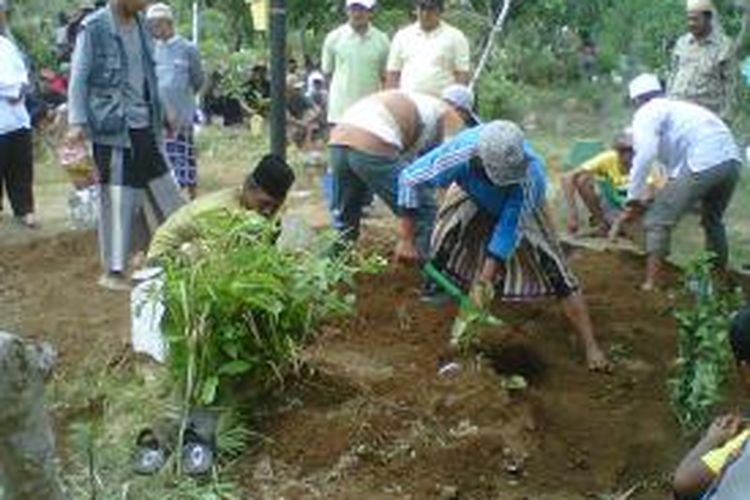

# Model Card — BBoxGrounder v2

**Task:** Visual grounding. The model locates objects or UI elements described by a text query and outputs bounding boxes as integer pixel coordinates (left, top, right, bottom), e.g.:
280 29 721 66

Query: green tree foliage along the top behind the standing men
12 0 741 90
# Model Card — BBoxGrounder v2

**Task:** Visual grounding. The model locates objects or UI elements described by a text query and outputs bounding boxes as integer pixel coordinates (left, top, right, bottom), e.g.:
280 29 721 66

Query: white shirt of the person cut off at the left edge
0 35 31 135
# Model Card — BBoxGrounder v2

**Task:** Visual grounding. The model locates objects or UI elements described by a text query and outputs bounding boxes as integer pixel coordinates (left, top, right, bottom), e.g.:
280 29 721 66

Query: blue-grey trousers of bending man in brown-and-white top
330 146 437 257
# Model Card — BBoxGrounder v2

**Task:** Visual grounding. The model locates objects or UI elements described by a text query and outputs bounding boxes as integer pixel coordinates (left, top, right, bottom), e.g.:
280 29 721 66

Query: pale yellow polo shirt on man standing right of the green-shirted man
387 21 470 97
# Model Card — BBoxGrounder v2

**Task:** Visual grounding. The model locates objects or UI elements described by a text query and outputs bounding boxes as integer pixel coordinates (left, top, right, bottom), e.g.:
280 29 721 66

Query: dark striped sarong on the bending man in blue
431 185 579 300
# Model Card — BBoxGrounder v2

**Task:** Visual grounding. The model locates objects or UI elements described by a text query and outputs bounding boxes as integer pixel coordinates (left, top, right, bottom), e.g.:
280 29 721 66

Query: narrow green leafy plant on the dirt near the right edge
668 255 741 433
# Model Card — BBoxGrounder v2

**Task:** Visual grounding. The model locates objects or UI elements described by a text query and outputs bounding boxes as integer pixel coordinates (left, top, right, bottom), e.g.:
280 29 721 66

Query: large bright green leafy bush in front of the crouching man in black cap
164 216 372 406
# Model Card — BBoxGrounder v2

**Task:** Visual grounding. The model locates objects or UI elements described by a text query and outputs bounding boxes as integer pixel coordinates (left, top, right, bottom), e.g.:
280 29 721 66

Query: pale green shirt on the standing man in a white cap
321 24 389 123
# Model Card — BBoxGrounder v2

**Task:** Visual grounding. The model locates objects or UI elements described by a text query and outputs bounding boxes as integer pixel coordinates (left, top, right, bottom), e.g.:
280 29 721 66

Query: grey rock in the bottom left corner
0 332 65 500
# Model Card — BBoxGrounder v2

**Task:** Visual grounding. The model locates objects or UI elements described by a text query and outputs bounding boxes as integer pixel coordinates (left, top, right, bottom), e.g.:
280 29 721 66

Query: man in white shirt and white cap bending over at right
610 74 742 291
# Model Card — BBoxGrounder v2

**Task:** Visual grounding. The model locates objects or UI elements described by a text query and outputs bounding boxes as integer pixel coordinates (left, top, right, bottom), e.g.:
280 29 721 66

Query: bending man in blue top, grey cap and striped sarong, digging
396 121 609 371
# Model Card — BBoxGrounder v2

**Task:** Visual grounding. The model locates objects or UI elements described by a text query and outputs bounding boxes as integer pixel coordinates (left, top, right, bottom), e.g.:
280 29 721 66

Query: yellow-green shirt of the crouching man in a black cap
148 188 247 260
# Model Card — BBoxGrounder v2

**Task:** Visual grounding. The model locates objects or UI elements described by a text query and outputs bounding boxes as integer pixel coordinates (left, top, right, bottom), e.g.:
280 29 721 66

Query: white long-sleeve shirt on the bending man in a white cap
628 98 740 200
